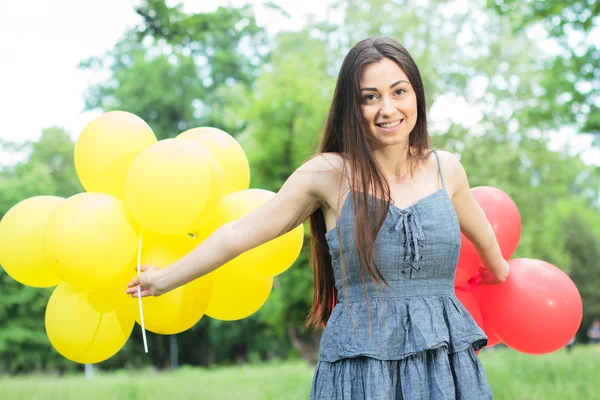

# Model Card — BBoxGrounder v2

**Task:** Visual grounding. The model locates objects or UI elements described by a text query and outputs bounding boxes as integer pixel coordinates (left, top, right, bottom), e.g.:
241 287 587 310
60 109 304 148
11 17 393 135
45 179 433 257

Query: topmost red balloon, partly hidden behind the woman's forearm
471 186 521 260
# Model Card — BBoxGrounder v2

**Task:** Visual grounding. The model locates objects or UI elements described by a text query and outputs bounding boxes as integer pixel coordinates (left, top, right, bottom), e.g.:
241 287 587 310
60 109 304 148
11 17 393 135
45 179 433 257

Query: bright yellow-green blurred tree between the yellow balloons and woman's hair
241 32 335 191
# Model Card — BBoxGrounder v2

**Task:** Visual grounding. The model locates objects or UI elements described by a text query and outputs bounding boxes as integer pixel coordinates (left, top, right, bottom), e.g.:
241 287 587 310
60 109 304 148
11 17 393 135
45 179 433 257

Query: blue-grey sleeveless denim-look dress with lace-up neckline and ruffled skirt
310 152 492 400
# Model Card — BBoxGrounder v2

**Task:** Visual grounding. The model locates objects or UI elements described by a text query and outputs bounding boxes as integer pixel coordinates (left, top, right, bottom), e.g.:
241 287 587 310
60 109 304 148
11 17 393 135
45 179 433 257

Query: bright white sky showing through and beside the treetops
0 0 600 165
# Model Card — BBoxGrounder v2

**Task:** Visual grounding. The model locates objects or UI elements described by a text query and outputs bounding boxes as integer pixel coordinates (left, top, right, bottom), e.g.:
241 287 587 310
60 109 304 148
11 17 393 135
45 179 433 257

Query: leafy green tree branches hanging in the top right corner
487 0 600 141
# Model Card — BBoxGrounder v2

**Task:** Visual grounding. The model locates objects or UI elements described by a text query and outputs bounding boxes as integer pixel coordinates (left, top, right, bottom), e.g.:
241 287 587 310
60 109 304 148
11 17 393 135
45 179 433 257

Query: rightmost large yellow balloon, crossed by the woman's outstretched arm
218 189 304 278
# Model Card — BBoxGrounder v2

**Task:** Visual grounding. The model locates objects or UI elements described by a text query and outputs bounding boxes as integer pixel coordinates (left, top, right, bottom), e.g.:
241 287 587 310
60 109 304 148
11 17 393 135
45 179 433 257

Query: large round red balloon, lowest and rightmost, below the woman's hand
479 258 583 354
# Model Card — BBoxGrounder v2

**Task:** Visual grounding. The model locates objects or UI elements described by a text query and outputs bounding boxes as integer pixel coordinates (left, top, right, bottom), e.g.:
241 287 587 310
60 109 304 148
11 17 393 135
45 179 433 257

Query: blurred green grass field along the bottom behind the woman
0 346 600 400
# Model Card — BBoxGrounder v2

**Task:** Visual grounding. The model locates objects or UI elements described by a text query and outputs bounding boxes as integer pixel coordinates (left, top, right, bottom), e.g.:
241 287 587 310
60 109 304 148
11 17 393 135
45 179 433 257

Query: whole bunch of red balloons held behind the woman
455 186 583 354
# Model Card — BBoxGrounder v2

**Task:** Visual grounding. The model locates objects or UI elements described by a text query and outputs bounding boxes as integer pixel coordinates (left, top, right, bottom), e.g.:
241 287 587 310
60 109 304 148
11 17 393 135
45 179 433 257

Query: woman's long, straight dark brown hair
307 37 430 327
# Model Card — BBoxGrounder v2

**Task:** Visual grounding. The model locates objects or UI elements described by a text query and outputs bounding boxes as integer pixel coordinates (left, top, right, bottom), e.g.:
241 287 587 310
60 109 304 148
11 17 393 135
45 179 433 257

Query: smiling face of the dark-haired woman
360 58 418 148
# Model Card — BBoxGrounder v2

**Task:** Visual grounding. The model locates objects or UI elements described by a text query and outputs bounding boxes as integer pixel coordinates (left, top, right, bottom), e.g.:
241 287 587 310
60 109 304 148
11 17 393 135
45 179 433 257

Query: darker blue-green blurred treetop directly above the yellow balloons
81 0 265 139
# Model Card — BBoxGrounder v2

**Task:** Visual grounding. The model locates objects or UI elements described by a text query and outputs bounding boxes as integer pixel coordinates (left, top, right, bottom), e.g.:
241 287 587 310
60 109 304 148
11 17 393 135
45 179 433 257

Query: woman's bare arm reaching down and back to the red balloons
444 153 509 284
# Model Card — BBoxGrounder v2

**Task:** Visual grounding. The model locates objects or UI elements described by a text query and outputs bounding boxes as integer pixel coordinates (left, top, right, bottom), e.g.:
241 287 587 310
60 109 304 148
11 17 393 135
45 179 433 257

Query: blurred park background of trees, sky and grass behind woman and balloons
0 0 600 400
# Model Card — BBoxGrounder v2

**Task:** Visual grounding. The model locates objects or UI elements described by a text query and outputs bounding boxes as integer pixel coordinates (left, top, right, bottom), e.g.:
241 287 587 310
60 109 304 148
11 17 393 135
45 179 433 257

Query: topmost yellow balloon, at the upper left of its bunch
75 111 156 200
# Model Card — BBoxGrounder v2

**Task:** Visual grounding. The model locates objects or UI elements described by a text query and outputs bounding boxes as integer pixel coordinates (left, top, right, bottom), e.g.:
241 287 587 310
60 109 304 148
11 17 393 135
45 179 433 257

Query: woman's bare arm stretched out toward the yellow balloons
126 158 332 297
